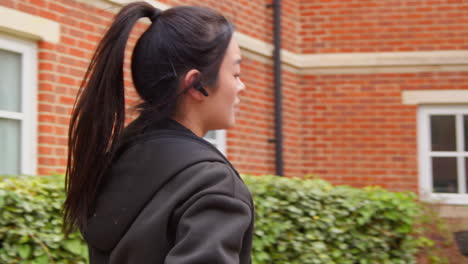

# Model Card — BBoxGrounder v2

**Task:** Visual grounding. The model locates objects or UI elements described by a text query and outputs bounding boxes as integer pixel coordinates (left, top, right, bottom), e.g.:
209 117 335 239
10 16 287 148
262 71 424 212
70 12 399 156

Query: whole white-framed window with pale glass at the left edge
0 35 37 175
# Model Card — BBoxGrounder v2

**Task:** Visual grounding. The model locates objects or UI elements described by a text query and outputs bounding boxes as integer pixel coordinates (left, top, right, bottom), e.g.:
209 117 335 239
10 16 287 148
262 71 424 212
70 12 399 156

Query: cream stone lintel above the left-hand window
0 6 60 43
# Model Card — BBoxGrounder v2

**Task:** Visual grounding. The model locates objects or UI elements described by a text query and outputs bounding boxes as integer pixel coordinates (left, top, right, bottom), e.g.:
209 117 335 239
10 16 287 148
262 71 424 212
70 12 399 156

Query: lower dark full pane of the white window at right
432 157 458 193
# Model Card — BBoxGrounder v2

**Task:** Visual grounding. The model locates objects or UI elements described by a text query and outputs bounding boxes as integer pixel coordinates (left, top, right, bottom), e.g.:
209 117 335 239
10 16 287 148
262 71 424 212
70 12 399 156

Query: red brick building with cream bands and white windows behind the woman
0 0 468 215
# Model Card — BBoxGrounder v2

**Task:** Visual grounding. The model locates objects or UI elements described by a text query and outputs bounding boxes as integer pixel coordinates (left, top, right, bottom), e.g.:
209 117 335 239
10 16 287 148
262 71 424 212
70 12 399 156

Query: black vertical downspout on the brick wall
268 0 283 176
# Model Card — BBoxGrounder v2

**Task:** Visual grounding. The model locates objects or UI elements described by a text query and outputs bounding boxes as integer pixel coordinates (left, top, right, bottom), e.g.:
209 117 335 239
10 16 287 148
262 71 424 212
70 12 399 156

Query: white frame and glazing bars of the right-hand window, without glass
418 105 468 204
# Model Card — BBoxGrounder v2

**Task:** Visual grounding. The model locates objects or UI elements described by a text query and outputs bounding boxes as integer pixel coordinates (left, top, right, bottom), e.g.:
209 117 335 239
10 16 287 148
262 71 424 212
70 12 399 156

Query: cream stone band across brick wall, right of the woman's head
238 32 468 70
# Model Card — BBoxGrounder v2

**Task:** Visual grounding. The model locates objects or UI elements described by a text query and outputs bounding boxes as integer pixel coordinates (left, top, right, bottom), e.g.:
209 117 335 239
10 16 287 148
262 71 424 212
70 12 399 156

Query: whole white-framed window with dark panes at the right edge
418 106 468 204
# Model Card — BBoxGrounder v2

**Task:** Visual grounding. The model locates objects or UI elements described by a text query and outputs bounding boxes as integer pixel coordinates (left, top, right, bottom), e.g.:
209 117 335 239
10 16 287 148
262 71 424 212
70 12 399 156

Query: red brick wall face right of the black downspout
297 0 468 191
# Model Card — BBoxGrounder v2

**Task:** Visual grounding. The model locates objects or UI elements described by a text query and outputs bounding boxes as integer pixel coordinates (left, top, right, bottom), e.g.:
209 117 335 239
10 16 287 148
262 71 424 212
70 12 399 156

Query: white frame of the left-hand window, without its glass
0 34 37 175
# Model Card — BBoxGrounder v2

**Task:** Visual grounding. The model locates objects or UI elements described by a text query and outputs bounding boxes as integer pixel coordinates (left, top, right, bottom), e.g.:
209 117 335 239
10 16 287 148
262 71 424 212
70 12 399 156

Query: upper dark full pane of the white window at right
431 115 457 151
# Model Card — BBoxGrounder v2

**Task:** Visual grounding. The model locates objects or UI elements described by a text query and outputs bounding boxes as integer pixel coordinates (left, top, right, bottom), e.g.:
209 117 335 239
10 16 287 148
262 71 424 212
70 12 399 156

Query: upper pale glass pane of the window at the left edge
0 49 21 112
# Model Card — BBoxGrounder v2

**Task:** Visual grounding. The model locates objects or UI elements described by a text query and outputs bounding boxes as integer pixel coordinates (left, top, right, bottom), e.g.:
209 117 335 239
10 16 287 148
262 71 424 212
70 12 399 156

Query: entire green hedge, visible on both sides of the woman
0 176 420 264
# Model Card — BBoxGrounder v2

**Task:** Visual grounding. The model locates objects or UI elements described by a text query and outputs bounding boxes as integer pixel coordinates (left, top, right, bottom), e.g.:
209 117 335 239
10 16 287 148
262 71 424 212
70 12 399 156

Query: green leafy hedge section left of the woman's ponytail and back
0 176 88 264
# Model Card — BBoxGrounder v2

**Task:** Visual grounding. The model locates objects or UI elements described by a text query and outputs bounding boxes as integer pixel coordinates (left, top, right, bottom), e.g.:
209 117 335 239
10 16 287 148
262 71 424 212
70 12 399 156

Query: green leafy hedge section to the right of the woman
244 176 420 264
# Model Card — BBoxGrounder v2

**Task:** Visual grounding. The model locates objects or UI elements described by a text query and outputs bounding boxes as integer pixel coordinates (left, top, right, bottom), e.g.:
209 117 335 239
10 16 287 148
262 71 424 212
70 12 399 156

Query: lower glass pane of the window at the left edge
0 119 21 175
